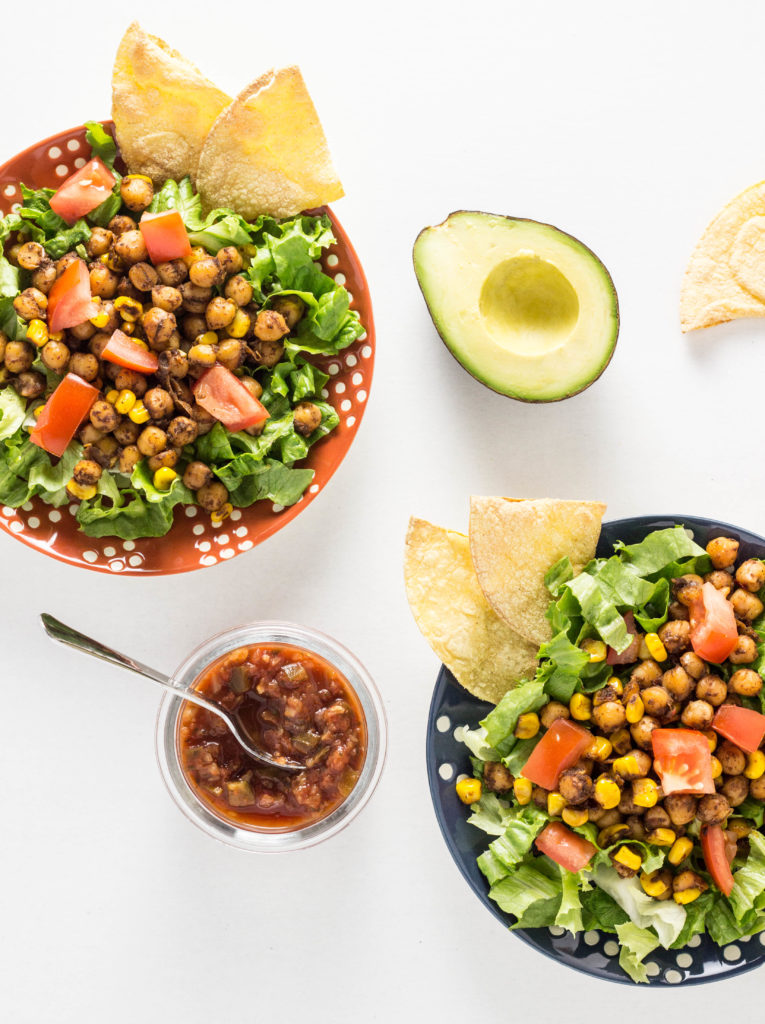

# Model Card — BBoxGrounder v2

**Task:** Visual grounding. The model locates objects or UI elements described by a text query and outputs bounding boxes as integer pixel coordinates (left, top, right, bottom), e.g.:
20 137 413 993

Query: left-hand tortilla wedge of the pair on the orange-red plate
112 22 231 183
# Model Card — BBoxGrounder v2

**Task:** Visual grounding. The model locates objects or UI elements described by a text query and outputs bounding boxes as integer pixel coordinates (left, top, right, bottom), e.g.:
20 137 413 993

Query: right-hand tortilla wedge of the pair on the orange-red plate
197 68 343 219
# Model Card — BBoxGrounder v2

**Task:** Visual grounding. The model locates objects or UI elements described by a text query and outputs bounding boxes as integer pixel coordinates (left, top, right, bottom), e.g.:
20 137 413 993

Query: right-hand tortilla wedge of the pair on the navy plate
470 498 605 645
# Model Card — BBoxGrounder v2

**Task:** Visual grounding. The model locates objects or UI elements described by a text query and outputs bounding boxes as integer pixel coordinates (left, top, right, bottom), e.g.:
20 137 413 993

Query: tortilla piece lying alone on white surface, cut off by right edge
680 181 765 332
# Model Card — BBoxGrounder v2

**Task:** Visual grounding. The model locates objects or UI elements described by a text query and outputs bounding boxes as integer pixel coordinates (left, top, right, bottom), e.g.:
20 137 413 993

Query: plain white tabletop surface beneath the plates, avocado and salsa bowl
0 0 765 1024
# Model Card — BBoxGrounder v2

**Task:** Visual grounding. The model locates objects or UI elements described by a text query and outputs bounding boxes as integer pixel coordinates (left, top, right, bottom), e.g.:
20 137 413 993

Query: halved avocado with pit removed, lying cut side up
413 210 619 401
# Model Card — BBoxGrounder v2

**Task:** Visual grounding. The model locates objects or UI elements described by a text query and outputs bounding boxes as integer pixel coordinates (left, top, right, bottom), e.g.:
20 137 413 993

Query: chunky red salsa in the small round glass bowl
179 643 367 830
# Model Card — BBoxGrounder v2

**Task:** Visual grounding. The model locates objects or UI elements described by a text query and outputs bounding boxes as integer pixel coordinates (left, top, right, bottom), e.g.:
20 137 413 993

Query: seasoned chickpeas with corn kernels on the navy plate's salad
482 537 765 903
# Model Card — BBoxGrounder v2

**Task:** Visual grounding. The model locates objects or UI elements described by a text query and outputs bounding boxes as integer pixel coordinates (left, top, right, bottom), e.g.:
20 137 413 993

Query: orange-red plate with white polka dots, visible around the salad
0 119 375 575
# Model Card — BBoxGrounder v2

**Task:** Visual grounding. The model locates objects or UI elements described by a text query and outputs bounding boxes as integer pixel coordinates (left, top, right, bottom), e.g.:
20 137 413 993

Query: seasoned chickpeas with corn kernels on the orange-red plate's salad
0 175 322 512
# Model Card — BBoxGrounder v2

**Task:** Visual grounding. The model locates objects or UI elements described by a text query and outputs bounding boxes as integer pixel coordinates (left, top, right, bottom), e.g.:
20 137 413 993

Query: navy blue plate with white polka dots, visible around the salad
426 516 765 985
